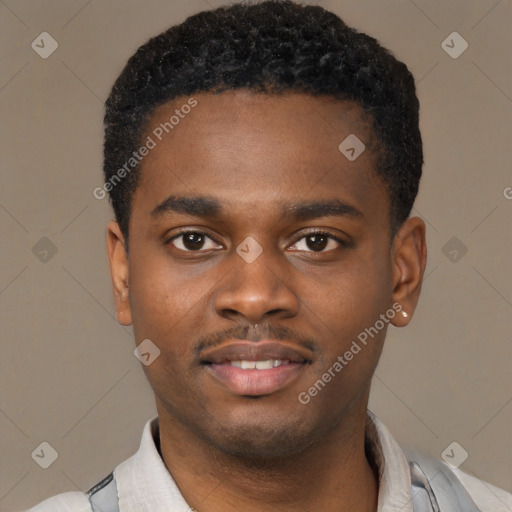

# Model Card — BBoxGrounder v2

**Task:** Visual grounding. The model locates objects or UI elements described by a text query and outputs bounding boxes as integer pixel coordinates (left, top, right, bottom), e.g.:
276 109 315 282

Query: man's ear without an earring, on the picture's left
107 220 132 325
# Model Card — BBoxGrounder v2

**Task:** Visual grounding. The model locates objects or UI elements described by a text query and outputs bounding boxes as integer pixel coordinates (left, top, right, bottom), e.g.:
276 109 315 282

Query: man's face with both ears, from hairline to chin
109 91 425 457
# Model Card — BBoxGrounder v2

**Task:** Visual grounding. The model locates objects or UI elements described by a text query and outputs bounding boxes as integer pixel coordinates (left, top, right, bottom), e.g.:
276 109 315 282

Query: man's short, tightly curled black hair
104 0 423 242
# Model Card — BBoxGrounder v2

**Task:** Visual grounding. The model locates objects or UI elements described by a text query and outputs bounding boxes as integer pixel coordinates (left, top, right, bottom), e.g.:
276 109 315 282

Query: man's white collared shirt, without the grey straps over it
27 413 512 512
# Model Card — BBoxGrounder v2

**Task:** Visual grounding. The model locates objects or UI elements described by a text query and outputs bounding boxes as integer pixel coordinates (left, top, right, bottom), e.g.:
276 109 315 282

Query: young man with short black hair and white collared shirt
25 1 512 512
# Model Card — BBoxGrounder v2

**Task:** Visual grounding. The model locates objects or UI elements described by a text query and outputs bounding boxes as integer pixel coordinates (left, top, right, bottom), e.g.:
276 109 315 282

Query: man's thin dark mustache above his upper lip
193 322 318 358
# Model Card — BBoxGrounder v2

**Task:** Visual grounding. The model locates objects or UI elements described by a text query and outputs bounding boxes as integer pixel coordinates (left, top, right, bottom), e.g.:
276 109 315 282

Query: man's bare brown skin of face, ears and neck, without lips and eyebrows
107 90 426 512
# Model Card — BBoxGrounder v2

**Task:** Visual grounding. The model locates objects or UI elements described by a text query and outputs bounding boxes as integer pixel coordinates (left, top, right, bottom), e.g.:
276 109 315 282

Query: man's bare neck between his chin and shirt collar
157 404 378 512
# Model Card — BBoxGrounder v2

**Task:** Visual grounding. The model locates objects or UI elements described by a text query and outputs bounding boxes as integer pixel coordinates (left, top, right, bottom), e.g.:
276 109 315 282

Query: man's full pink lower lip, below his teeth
205 363 304 396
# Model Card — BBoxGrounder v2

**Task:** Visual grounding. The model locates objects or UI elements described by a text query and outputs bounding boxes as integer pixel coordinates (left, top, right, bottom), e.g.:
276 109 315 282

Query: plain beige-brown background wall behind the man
0 0 512 511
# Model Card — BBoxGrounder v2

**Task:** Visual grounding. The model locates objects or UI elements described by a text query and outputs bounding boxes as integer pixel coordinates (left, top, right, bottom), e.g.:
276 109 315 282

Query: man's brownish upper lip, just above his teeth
199 340 313 364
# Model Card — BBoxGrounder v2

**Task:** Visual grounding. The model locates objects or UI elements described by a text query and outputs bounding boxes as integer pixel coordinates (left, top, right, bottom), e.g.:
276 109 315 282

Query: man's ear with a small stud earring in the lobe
391 217 427 327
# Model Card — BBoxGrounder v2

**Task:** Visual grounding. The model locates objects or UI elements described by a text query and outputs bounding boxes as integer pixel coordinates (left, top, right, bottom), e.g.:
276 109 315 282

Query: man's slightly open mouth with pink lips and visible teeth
200 340 313 397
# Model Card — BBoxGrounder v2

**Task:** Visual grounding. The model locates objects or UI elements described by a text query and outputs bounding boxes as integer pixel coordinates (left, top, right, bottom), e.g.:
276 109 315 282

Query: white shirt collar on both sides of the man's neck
114 411 413 512
